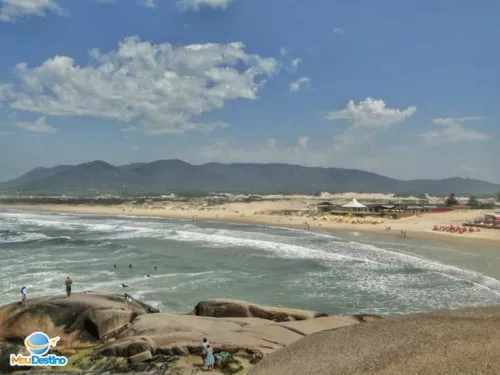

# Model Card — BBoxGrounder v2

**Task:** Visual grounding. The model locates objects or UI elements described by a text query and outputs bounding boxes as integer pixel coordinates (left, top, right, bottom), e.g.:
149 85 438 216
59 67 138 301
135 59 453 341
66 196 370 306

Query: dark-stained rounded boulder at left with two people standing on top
0 292 150 347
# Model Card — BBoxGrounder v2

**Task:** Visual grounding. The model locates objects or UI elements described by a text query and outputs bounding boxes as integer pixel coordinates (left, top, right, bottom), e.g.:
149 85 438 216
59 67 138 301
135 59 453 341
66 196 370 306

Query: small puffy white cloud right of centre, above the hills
324 98 417 148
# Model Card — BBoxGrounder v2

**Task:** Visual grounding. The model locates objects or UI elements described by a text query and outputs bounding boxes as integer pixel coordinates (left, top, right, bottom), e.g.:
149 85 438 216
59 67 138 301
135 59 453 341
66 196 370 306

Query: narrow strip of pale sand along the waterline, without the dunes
0 202 500 246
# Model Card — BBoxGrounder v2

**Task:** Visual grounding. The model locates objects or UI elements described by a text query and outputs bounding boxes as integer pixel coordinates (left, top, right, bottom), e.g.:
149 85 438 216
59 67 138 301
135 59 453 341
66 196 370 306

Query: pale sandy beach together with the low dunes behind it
0 197 500 245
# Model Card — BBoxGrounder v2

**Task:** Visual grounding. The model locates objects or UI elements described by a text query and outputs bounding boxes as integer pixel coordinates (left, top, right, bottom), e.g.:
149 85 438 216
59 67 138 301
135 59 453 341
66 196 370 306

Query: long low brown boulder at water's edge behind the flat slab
191 299 326 322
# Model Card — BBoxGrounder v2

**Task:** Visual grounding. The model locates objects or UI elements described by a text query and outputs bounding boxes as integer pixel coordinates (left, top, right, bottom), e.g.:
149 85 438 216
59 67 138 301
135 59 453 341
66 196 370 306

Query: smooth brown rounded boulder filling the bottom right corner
249 307 500 375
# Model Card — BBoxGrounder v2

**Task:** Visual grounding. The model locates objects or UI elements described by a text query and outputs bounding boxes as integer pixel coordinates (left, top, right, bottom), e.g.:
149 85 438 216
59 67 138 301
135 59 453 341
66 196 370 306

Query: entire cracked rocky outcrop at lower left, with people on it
0 292 376 374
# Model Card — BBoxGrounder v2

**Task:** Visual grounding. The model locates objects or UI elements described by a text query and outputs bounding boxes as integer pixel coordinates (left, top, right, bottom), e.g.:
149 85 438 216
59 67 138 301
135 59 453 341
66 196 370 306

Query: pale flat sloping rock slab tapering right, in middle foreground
102 313 366 356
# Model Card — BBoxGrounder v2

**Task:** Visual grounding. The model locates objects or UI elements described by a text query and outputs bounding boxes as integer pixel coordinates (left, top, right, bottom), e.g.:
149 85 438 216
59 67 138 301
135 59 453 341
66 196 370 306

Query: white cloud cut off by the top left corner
0 0 64 22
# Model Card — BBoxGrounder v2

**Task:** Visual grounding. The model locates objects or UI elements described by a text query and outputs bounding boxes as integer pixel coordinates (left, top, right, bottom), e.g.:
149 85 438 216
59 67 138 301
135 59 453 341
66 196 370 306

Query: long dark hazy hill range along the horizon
0 160 500 196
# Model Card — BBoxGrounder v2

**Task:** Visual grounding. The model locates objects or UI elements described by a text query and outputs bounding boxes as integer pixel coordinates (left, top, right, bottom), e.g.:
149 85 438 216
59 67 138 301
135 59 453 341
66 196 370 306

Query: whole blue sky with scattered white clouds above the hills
0 0 500 183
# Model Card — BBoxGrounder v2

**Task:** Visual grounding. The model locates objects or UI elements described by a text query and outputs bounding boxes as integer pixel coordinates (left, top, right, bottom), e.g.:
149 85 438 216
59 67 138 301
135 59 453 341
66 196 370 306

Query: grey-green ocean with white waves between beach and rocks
0 210 500 315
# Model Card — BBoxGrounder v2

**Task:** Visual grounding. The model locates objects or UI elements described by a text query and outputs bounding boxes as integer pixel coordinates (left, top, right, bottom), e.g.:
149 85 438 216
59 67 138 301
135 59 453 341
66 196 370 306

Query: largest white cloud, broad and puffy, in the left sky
0 37 277 134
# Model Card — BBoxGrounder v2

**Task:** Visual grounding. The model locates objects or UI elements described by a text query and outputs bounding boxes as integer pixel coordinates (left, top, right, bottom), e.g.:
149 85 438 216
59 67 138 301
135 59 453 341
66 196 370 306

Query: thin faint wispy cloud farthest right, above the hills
420 116 490 146
